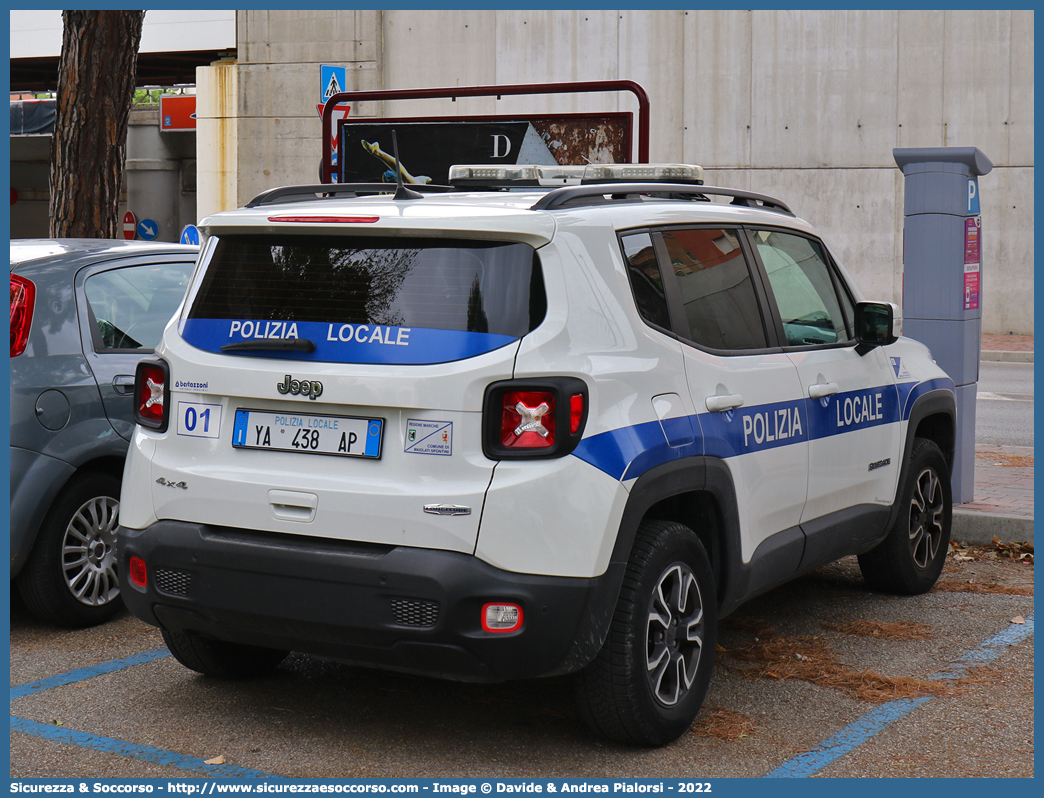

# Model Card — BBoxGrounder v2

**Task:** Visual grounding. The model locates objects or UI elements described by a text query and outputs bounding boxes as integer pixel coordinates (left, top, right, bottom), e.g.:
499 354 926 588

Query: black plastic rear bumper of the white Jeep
118 521 622 681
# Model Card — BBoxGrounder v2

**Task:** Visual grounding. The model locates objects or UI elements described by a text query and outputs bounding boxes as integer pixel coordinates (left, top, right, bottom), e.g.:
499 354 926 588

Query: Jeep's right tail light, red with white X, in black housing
482 377 588 460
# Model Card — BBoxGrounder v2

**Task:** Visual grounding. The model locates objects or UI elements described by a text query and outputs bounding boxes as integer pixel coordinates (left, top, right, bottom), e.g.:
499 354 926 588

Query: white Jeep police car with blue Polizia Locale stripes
119 165 955 745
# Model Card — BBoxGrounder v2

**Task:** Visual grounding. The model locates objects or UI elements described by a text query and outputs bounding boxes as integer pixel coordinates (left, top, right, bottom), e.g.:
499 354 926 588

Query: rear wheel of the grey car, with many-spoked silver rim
16 472 123 628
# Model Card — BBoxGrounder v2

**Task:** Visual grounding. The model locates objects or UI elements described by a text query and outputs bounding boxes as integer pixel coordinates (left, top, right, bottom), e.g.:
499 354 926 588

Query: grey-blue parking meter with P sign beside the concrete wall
892 147 993 502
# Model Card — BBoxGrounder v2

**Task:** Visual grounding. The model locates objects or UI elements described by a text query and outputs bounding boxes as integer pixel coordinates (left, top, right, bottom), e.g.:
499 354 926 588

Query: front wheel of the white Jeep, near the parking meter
859 438 953 595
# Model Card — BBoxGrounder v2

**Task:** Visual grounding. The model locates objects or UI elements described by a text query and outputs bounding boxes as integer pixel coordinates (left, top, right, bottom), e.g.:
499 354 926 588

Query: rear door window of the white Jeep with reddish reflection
663 229 767 350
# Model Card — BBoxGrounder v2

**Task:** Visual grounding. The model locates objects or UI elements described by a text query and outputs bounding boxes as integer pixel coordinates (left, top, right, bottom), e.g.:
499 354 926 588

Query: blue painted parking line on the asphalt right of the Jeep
764 615 1034 778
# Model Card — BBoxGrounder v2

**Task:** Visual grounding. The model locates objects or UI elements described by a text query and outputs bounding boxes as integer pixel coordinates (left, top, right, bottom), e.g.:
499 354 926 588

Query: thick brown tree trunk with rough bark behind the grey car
50 10 145 238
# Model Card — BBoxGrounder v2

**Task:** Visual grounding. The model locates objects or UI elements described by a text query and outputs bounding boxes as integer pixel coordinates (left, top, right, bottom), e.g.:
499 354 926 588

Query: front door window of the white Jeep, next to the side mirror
754 230 852 347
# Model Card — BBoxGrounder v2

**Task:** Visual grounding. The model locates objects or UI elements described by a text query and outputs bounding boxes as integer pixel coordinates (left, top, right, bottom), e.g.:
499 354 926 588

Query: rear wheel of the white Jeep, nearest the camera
576 521 717 746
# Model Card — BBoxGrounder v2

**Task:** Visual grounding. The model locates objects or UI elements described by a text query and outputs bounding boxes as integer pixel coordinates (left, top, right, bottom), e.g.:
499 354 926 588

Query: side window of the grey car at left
84 263 194 352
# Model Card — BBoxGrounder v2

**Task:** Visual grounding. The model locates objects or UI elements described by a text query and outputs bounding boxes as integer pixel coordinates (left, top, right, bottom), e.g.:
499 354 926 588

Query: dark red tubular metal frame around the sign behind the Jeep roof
322 80 649 183
